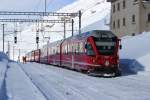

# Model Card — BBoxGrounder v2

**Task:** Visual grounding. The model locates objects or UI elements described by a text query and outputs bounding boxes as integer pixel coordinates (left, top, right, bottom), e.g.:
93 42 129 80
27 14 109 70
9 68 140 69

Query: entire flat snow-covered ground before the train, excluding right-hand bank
0 62 150 100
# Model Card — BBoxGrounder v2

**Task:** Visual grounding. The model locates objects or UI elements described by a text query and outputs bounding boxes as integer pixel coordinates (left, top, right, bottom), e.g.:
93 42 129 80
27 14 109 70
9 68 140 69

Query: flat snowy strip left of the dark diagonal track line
6 62 46 100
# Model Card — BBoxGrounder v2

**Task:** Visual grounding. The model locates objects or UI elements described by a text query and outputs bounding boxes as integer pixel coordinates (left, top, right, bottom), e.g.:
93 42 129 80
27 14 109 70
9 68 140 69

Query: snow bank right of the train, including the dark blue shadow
120 32 150 74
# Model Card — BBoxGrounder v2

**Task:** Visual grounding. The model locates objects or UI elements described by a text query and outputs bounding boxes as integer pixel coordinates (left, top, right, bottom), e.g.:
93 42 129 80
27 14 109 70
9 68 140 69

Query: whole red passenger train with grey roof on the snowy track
26 30 121 76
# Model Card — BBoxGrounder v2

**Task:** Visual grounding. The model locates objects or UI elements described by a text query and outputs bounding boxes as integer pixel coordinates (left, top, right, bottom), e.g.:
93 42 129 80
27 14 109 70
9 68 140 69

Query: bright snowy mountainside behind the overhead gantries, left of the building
42 0 110 42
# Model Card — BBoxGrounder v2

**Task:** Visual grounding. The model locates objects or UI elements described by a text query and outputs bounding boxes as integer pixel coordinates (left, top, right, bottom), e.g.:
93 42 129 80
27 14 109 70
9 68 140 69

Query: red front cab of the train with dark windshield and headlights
85 31 121 76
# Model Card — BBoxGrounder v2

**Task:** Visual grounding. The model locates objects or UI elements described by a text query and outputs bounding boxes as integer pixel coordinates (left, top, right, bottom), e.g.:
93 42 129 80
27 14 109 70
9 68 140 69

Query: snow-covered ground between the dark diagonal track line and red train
20 64 150 100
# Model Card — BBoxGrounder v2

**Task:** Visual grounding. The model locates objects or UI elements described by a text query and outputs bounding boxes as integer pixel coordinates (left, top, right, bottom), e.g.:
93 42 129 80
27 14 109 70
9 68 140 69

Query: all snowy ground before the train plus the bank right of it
0 32 150 100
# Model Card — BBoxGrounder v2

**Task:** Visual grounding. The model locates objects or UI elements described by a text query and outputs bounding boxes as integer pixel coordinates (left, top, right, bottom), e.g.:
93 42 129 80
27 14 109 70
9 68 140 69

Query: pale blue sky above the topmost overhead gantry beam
0 0 75 11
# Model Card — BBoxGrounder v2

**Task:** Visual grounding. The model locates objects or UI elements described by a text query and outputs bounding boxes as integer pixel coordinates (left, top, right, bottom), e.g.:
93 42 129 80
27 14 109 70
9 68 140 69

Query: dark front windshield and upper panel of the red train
93 31 117 55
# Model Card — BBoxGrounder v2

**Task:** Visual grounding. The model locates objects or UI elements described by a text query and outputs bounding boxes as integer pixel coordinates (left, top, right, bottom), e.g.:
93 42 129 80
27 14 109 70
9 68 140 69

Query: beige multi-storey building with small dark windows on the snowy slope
107 0 150 37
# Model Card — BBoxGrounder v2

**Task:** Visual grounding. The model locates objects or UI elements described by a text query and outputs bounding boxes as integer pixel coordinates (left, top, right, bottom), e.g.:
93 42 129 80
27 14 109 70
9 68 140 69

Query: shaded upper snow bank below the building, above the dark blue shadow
120 32 150 59
